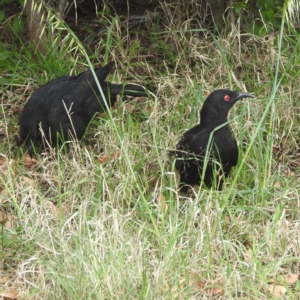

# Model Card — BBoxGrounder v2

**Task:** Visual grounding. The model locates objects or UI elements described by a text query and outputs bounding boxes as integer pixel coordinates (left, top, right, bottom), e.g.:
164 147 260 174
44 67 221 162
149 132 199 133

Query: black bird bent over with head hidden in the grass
19 62 148 157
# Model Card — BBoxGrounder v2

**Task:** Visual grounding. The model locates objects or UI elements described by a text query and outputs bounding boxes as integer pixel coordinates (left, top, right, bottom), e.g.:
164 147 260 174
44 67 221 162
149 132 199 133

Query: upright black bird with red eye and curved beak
172 90 253 193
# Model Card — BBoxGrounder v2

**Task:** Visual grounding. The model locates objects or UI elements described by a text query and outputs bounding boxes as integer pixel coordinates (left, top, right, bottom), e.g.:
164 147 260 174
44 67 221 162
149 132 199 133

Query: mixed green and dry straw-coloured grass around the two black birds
0 2 300 299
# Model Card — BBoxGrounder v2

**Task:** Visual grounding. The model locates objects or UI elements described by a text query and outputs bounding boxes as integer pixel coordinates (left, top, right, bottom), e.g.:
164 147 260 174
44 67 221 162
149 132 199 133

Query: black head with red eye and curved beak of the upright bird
200 90 254 122
